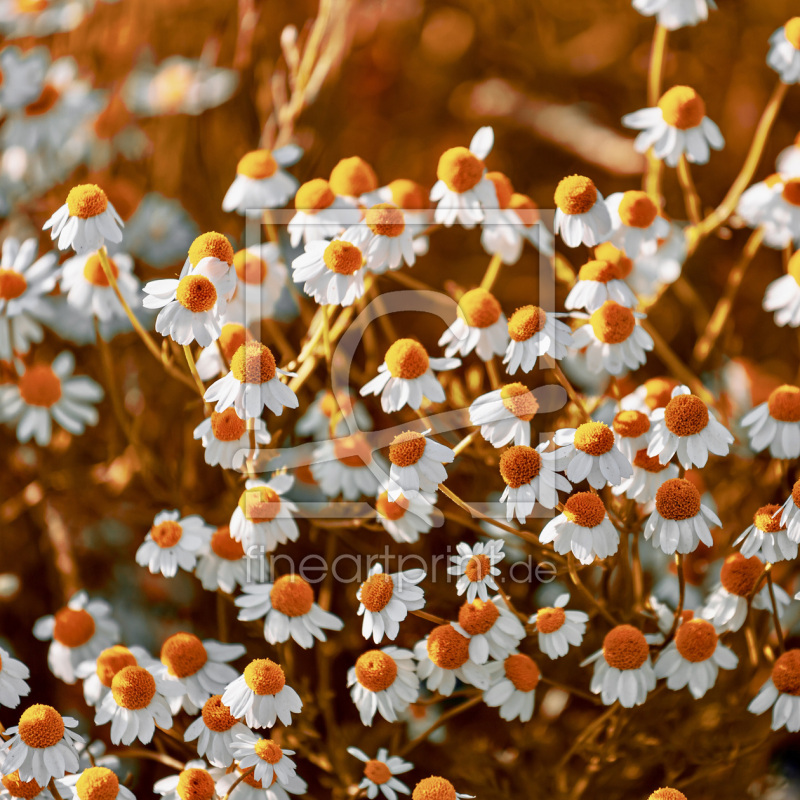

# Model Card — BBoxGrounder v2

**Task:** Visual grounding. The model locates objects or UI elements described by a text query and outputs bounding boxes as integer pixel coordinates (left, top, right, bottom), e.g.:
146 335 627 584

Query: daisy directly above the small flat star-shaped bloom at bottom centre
347 647 419 726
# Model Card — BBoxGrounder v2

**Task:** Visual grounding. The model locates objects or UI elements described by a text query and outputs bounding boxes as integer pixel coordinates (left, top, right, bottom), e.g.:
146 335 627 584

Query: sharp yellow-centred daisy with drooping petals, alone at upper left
44 183 124 255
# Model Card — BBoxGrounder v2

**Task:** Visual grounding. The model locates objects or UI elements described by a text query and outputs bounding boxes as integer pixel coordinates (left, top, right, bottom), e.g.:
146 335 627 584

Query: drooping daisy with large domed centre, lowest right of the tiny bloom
581 625 656 708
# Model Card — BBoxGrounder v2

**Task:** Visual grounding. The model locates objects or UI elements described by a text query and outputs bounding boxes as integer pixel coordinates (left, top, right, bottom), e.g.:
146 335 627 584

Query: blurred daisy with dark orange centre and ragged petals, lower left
33 591 119 683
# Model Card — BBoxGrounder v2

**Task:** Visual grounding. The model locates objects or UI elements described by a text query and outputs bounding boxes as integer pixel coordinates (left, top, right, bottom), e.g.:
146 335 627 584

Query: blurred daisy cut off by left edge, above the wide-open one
0 234 58 361
